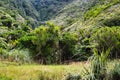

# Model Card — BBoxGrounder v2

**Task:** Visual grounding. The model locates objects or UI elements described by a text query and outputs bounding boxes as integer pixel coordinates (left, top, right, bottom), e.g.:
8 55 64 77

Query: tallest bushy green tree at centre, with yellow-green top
33 23 60 63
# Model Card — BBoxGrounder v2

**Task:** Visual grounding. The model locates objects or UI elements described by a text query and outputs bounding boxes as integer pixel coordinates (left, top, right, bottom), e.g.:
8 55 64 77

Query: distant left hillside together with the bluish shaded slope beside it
0 0 74 28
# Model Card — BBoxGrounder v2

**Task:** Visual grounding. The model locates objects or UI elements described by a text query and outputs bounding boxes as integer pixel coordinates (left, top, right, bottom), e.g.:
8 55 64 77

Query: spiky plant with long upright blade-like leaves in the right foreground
91 49 110 80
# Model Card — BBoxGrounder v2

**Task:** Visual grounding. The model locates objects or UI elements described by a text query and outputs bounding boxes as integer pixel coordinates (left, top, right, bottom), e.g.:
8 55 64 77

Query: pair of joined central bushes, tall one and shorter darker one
33 23 78 64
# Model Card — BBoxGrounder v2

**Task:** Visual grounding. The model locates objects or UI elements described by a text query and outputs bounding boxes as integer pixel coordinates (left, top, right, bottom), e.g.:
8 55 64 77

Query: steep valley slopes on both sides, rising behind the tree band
0 0 120 30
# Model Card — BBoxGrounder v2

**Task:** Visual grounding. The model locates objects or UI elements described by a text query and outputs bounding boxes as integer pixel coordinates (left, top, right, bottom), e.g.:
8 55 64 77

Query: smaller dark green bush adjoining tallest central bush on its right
60 32 78 61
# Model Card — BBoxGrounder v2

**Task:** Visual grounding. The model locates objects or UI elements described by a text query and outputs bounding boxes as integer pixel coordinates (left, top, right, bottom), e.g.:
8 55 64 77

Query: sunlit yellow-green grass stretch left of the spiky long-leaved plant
0 63 84 80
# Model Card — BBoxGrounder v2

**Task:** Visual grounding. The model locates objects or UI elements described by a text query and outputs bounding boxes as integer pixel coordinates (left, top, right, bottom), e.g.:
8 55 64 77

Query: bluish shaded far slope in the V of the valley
31 0 72 21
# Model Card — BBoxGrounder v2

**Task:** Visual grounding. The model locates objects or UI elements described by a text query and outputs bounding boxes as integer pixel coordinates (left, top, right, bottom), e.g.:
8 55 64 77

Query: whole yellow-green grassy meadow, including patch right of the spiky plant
0 60 120 80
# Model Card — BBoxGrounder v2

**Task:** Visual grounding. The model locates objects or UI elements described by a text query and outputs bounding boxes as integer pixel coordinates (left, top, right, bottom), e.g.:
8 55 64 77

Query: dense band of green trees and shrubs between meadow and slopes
0 16 120 64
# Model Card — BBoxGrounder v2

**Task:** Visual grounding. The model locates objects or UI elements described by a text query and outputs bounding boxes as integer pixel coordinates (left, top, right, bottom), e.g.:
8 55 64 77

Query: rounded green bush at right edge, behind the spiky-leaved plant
91 27 120 57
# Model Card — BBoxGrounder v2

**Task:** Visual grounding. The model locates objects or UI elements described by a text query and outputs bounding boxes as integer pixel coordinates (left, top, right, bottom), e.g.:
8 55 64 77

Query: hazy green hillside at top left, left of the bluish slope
0 0 39 27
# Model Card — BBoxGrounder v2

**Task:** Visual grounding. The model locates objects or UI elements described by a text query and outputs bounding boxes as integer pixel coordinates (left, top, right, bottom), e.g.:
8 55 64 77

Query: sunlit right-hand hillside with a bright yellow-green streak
52 0 120 30
